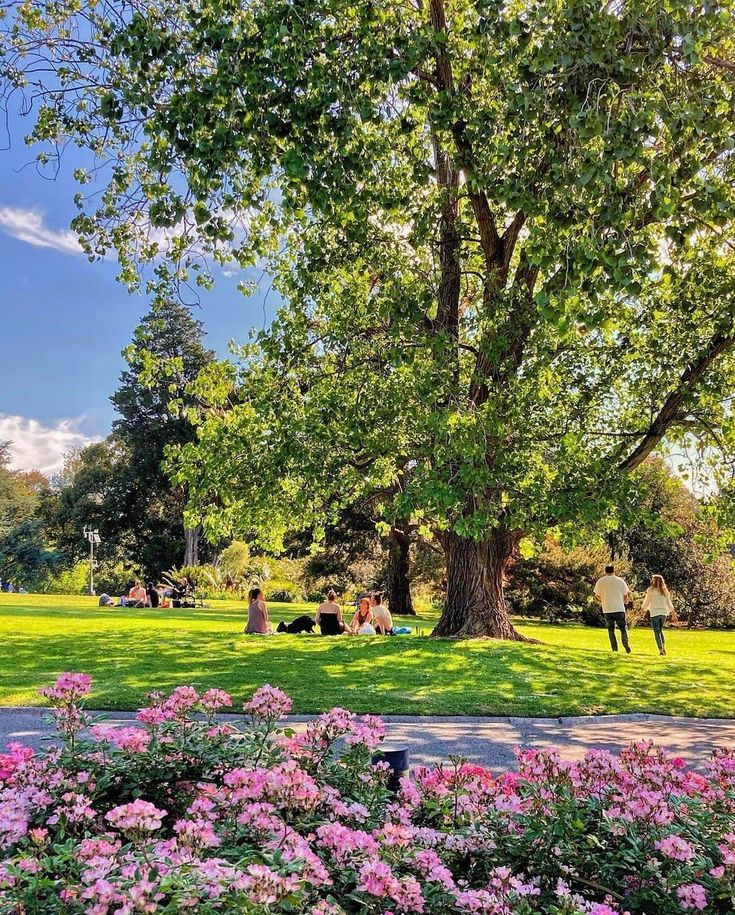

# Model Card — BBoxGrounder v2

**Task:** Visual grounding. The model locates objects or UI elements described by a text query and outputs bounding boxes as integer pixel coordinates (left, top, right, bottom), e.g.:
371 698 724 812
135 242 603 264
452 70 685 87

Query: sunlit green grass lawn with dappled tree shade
0 594 735 717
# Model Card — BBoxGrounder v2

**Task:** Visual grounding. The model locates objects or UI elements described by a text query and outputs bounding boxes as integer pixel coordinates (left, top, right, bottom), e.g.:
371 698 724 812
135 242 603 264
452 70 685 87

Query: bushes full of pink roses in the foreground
0 674 735 915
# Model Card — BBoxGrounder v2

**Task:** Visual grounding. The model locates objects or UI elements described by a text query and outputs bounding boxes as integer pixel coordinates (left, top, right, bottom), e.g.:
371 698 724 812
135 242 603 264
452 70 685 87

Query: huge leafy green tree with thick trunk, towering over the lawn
5 0 735 638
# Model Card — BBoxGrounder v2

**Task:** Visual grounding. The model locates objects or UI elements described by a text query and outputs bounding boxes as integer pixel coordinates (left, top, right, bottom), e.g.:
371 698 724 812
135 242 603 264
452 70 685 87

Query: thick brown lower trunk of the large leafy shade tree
432 529 529 642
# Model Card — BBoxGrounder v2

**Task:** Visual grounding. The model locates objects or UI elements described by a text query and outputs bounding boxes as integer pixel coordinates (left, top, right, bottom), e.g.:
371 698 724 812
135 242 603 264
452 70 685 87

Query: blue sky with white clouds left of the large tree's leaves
0 112 277 470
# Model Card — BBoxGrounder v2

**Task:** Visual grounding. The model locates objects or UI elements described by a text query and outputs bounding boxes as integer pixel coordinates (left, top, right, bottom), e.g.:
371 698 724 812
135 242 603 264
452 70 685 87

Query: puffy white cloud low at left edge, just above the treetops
0 413 95 474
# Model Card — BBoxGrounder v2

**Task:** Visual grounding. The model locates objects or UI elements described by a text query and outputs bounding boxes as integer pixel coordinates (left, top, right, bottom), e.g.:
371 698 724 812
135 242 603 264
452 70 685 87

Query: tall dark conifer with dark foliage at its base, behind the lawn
48 301 213 577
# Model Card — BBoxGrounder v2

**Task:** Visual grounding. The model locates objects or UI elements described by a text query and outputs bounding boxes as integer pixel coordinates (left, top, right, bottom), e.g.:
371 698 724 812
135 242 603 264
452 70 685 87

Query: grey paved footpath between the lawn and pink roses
0 708 735 769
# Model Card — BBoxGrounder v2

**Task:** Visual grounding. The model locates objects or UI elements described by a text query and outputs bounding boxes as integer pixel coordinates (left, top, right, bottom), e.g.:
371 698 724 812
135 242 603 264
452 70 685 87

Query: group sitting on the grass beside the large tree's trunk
245 588 396 635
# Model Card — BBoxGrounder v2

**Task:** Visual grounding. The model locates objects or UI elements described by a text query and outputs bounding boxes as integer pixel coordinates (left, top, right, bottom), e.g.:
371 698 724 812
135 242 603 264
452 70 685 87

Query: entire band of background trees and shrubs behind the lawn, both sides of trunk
0 288 735 627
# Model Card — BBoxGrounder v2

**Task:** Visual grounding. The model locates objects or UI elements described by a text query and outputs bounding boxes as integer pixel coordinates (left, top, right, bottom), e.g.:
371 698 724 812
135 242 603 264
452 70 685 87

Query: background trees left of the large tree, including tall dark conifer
0 301 213 592
